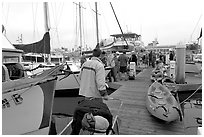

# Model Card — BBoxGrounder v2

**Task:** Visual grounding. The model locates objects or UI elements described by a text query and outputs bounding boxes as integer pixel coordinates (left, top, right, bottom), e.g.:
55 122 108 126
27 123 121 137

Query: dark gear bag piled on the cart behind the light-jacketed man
71 99 113 135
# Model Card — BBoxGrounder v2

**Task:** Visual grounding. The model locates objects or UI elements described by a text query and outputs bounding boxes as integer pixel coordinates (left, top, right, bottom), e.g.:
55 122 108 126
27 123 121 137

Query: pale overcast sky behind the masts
1 0 203 49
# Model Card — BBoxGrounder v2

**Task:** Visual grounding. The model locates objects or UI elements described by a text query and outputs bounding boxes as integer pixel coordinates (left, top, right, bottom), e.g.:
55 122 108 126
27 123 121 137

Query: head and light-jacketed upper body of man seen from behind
79 49 108 101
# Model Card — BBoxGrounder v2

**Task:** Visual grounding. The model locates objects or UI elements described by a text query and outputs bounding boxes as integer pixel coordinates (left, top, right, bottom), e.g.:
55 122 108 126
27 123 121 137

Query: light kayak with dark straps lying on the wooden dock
146 81 182 122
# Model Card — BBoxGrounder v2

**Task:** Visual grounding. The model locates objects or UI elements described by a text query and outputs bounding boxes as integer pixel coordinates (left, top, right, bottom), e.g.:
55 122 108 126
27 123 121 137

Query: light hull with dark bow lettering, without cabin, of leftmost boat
2 62 60 135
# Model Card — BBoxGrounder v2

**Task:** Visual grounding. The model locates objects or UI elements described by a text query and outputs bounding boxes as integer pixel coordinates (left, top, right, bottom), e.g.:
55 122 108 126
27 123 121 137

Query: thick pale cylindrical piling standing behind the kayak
175 45 186 84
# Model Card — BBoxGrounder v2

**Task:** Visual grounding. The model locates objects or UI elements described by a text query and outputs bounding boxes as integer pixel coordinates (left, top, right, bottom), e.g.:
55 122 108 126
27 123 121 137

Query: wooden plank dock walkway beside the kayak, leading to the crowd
110 68 185 135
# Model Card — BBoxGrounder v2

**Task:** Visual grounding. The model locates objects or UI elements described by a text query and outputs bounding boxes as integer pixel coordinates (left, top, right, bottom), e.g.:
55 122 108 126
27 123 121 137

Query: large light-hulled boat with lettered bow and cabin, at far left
2 3 63 135
